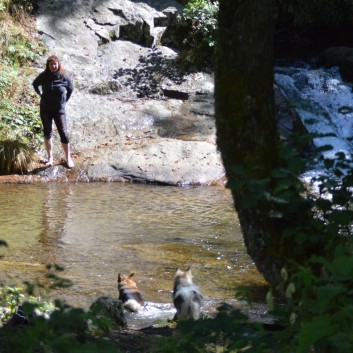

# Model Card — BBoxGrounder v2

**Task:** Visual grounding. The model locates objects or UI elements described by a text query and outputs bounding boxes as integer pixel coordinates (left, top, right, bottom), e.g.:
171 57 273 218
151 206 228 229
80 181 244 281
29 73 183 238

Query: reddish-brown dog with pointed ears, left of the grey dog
118 273 144 313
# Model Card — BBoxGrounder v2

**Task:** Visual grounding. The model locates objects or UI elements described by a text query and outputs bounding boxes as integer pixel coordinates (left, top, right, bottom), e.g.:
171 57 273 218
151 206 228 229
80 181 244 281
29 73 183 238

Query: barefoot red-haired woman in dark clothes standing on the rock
33 55 74 168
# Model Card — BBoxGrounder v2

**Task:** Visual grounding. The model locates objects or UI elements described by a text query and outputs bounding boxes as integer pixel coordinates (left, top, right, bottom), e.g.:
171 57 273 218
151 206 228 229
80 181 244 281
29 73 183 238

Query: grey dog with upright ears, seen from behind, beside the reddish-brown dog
173 267 203 320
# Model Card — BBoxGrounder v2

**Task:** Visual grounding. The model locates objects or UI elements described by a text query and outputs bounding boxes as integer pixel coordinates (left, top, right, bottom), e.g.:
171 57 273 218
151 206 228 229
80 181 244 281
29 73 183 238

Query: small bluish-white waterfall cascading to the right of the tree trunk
275 63 353 159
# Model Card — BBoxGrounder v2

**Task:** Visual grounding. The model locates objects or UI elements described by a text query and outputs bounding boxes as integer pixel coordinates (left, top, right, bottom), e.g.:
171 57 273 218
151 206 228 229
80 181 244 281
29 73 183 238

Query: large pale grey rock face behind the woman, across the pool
16 0 224 185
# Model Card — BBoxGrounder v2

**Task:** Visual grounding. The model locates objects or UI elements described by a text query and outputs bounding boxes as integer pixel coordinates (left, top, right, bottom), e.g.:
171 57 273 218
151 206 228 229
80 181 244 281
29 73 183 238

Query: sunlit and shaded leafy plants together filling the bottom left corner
0 265 118 353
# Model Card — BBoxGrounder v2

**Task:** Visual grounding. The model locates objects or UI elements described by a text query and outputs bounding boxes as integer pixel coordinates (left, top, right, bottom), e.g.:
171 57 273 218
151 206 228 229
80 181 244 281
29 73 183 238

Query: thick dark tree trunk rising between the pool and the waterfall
215 0 286 283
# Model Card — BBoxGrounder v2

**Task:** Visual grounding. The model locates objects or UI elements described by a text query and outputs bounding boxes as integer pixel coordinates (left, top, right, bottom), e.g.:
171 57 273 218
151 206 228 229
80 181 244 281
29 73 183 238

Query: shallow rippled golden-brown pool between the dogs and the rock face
0 183 264 306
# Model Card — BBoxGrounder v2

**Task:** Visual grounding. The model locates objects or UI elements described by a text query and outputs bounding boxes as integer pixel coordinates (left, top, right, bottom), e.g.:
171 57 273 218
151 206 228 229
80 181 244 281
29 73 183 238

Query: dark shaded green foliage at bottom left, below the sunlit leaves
0 301 118 353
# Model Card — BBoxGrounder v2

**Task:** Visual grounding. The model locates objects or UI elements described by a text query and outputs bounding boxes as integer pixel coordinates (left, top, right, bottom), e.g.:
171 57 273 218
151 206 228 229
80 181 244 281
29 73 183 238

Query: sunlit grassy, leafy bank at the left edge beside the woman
0 0 46 162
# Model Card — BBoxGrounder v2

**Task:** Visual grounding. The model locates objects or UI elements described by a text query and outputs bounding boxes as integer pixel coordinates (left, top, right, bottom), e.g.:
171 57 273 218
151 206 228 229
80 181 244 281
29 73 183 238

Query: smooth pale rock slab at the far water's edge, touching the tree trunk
86 140 224 185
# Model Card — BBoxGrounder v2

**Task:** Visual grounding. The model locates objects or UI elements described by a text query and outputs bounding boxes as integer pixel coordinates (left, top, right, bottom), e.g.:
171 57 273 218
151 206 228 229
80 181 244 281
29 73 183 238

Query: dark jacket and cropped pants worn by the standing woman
33 71 74 143
